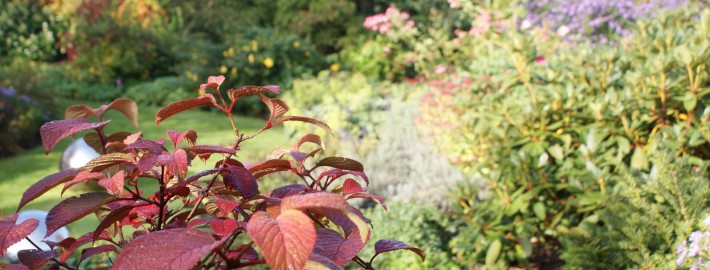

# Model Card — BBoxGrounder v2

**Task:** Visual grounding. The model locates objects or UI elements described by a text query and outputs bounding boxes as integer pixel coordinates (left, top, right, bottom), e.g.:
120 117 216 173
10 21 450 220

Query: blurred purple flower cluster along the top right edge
521 0 689 44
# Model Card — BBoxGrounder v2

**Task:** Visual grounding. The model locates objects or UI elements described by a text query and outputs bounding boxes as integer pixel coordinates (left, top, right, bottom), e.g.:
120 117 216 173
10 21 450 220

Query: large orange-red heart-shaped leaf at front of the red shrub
247 210 316 269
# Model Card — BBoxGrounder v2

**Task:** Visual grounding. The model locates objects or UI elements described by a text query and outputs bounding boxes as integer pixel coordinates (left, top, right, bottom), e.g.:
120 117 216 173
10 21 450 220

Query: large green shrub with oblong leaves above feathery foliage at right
425 8 710 267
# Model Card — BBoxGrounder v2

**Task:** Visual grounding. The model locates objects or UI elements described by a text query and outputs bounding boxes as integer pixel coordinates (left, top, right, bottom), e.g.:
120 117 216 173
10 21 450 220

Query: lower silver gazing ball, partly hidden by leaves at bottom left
5 210 69 262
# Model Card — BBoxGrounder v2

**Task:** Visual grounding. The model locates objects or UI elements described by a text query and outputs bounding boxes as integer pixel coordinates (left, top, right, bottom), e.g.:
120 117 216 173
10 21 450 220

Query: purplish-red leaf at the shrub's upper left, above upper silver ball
39 119 111 154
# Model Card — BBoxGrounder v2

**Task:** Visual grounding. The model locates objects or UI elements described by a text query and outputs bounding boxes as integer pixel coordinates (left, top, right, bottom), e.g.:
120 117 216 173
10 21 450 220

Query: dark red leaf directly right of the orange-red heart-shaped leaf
313 228 365 266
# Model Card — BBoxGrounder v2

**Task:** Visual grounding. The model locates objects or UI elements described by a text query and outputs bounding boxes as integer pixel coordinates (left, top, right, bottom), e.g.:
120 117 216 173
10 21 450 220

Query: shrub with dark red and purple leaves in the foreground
0 76 424 269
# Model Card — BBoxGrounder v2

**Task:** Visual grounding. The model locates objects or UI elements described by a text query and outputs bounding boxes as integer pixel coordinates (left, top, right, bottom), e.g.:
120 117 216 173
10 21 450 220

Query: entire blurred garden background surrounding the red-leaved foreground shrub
0 0 710 269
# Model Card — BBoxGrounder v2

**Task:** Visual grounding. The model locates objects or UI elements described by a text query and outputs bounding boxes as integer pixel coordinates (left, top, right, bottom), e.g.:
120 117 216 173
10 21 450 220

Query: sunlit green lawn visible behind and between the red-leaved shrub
0 102 292 235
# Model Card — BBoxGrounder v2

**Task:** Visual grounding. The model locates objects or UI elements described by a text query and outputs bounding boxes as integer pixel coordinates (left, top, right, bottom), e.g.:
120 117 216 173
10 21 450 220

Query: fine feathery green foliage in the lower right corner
562 151 710 269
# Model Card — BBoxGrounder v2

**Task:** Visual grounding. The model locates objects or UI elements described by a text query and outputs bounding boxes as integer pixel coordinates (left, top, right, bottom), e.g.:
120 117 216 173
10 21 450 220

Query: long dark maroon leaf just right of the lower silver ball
45 192 115 237
